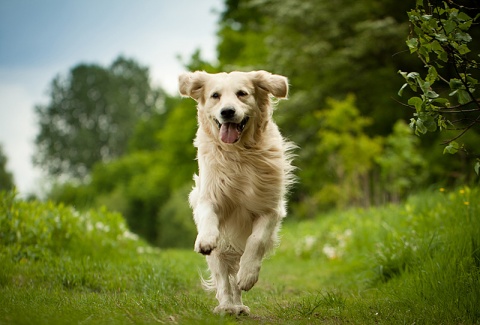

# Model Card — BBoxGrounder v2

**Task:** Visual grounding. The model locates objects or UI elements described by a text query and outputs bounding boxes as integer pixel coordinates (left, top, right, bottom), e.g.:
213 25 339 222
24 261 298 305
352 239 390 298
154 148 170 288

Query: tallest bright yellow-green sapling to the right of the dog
309 95 383 207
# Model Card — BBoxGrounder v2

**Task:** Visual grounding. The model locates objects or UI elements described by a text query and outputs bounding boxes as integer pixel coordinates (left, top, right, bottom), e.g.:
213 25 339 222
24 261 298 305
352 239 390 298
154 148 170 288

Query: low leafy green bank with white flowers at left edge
0 192 143 261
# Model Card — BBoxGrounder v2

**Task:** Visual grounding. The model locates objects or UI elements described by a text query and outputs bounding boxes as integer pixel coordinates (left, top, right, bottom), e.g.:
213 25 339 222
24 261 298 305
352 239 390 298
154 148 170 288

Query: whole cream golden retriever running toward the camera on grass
179 71 295 315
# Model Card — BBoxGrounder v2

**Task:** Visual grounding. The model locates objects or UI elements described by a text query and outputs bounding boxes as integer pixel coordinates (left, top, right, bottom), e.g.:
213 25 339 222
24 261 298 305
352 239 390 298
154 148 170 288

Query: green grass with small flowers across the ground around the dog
0 188 480 324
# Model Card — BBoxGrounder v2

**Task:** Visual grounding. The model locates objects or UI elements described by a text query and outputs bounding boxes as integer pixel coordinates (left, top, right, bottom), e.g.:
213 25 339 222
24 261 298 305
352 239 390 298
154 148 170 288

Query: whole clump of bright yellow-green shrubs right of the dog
294 94 427 218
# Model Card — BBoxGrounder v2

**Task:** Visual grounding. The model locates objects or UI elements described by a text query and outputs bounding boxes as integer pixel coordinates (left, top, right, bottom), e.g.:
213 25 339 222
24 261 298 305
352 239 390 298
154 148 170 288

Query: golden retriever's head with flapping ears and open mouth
179 71 288 144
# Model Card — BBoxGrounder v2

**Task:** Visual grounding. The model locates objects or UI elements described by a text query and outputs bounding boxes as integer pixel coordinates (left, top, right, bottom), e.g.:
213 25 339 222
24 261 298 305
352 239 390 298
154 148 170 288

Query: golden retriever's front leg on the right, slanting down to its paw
237 215 279 291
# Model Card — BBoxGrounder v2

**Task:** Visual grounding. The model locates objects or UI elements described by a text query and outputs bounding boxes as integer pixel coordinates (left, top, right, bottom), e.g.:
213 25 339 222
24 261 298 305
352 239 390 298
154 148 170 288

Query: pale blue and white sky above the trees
0 0 223 195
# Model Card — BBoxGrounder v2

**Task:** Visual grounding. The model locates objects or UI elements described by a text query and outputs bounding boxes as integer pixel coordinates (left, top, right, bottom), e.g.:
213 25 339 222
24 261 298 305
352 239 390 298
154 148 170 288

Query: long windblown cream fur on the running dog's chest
198 140 285 216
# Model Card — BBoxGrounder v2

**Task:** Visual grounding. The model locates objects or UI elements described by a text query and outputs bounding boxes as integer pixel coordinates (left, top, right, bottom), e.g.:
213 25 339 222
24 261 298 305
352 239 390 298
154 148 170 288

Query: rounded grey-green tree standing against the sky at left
34 57 163 180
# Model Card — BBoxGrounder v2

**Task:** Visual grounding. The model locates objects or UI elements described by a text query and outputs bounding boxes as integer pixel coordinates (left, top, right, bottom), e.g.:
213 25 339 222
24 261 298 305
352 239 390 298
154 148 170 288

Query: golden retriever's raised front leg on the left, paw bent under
193 201 220 255
